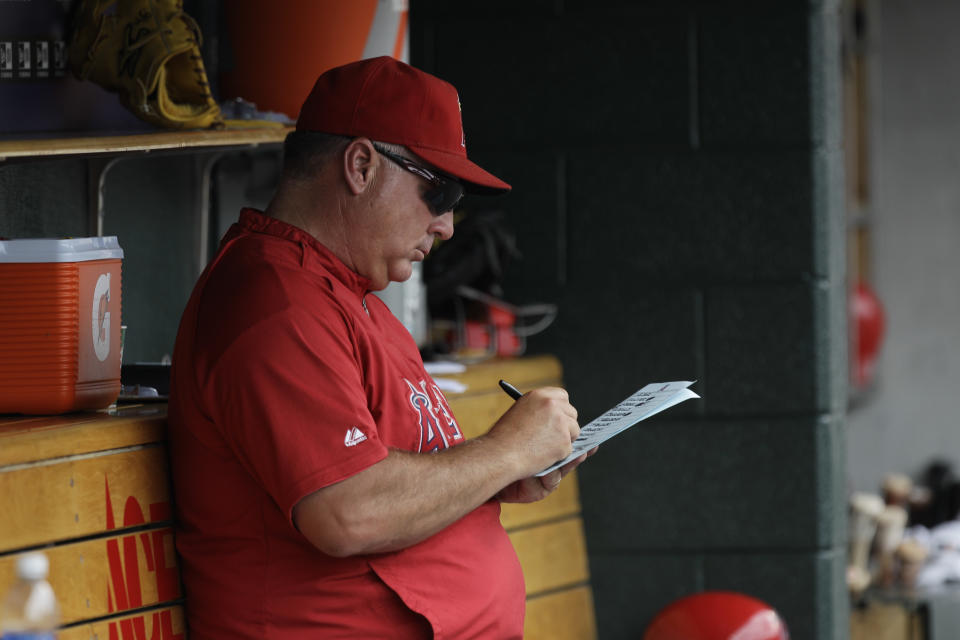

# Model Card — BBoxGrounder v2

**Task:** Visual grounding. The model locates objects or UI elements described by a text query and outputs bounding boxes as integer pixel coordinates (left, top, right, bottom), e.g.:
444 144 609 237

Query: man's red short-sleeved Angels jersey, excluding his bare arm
170 209 524 640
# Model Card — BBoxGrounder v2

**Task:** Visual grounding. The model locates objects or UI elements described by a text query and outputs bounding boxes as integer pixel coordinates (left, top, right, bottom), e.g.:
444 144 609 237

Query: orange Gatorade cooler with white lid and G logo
0 236 123 414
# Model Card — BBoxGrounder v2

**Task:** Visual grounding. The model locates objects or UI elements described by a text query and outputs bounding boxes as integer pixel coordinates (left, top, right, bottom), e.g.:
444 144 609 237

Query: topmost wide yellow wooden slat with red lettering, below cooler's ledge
0 445 171 552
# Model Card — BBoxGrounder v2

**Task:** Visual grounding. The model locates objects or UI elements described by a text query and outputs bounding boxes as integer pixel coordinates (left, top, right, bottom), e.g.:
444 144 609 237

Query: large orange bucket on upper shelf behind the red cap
220 0 408 119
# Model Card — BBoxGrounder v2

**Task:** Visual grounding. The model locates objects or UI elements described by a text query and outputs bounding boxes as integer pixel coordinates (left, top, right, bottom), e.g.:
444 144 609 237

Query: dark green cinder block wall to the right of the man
410 0 848 640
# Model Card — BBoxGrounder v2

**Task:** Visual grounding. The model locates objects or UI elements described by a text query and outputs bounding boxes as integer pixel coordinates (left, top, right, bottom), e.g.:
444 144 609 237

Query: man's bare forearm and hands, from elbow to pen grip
292 387 584 557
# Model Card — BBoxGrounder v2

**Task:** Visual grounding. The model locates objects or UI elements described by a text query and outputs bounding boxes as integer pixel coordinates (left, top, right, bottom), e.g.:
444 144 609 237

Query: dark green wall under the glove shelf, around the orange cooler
0 155 199 364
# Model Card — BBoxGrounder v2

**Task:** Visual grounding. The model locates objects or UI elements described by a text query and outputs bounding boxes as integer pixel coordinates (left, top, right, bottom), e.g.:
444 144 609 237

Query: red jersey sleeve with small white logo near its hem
201 307 387 522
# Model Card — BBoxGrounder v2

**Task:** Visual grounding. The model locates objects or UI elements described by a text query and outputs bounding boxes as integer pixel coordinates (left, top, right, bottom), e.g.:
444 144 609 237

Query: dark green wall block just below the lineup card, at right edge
579 416 844 553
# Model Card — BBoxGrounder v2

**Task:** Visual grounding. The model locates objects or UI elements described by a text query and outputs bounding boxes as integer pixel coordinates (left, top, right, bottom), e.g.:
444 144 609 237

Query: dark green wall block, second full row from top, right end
568 147 814 282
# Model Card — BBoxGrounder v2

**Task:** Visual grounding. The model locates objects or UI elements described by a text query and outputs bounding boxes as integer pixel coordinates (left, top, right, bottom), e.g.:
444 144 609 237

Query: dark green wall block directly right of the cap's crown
433 14 689 148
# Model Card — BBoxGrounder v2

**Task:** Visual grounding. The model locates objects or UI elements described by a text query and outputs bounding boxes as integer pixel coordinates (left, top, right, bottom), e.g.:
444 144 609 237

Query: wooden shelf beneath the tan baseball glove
0 127 293 162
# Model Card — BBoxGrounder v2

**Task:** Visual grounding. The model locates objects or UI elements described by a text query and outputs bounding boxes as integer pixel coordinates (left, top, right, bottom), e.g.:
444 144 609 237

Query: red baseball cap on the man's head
297 56 510 194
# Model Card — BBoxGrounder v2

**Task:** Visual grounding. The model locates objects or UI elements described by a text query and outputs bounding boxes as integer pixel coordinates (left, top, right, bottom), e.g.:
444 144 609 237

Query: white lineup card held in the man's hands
537 382 700 477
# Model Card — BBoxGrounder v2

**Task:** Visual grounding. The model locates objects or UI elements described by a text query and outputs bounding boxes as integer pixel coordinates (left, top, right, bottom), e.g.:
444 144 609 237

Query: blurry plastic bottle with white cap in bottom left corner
0 552 60 640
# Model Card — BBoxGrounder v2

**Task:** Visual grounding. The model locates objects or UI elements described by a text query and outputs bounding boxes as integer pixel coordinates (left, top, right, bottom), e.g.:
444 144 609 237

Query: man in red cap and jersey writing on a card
170 58 582 640
